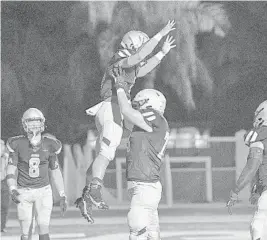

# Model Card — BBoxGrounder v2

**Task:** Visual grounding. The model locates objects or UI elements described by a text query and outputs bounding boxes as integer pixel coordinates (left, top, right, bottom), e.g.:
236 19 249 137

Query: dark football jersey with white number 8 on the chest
7 134 62 188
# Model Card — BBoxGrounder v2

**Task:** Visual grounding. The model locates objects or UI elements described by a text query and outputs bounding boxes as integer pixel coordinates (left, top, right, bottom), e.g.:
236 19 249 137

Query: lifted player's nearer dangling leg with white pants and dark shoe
88 102 123 208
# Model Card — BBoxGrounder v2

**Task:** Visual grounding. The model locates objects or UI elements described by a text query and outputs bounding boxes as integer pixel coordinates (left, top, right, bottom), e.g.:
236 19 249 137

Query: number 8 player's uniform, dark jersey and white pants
7 135 62 235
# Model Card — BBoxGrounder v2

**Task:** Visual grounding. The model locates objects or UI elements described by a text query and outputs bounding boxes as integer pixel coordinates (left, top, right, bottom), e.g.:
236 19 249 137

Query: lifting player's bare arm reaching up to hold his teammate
113 68 152 132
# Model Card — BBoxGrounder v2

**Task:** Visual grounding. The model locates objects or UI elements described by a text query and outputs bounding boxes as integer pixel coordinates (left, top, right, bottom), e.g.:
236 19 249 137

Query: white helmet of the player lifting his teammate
132 89 166 114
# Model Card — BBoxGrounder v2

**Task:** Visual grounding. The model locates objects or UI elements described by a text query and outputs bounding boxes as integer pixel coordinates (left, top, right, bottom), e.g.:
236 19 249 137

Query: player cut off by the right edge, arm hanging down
227 100 267 240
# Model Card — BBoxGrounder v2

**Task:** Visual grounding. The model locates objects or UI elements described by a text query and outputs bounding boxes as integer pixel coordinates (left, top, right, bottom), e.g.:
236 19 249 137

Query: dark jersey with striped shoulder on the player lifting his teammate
126 109 169 182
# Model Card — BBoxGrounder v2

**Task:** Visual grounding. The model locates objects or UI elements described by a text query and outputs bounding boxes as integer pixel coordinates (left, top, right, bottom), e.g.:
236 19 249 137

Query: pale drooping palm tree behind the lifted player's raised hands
88 1 230 110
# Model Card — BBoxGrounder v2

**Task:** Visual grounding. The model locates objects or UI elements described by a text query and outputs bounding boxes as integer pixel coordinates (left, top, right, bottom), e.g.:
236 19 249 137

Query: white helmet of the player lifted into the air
121 31 149 51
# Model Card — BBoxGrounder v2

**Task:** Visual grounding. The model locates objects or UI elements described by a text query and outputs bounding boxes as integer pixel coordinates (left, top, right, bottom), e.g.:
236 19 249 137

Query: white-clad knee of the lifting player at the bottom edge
127 208 148 240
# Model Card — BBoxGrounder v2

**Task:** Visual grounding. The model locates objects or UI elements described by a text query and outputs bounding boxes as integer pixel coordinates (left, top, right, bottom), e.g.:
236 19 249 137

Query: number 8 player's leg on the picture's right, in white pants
34 185 53 240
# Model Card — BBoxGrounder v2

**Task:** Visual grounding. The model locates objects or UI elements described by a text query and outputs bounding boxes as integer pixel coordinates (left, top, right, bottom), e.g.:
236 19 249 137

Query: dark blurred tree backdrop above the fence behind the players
1 1 267 144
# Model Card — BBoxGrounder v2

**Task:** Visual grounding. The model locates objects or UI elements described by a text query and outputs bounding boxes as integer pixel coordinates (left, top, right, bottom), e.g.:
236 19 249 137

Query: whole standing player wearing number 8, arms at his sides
7 108 67 240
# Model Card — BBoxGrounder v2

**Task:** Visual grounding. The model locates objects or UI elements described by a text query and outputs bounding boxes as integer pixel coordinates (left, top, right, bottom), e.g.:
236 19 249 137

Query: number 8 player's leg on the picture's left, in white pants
17 189 34 240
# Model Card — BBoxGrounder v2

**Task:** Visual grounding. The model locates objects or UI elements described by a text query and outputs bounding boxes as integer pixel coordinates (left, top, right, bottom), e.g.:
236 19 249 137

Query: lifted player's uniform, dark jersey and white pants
87 49 143 161
